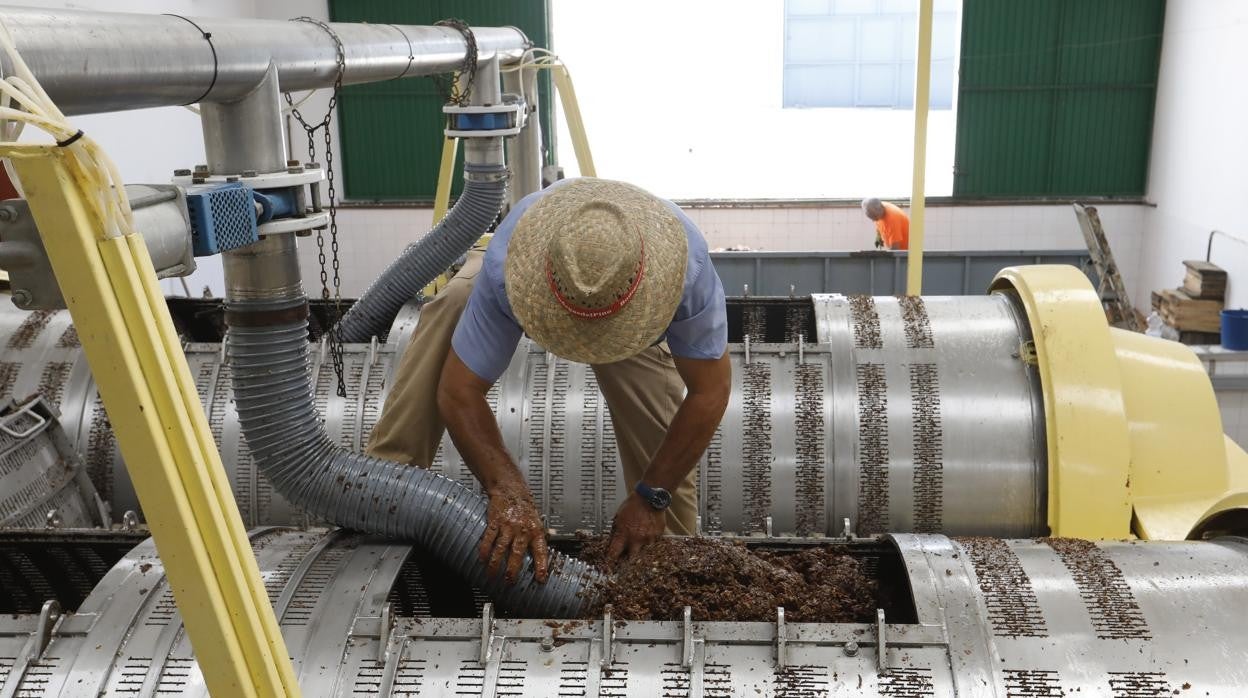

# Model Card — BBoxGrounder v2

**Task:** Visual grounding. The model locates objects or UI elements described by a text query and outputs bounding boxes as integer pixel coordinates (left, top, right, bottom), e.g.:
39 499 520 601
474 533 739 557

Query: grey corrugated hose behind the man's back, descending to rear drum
338 164 507 342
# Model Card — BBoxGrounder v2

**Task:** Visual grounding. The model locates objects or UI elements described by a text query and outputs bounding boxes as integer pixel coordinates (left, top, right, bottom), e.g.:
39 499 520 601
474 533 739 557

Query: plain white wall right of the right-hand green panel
1134 0 1248 307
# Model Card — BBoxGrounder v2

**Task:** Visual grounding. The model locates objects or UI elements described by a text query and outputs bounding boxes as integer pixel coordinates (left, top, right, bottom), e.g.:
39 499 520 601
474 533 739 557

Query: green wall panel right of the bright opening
953 0 1166 199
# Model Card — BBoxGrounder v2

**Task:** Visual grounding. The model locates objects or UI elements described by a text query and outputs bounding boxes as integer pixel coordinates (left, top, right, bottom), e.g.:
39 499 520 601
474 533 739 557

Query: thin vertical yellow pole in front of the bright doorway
906 0 934 296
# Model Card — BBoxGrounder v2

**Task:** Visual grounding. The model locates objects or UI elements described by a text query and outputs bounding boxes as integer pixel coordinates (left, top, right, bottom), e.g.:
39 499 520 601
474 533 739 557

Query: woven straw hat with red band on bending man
504 179 689 363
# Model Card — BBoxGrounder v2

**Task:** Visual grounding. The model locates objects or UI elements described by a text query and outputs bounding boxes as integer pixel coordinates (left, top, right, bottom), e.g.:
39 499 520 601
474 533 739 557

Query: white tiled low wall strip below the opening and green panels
324 204 1147 297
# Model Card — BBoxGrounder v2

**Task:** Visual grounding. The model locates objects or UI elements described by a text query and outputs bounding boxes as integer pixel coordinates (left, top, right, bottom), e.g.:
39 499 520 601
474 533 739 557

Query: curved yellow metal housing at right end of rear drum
992 265 1248 539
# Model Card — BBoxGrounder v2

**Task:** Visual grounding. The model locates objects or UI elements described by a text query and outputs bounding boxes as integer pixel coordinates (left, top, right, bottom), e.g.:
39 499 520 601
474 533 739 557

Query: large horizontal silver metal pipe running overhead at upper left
0 6 529 115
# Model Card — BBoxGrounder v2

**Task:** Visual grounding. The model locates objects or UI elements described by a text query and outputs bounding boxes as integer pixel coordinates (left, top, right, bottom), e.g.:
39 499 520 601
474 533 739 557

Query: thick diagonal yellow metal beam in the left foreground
7 145 300 697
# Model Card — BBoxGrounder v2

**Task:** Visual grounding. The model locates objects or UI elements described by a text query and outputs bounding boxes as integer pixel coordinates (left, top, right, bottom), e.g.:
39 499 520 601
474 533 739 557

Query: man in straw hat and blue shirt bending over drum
368 179 731 581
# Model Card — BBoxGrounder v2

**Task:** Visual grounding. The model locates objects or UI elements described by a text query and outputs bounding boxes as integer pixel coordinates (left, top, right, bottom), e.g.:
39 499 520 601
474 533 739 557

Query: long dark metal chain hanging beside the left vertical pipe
286 16 347 397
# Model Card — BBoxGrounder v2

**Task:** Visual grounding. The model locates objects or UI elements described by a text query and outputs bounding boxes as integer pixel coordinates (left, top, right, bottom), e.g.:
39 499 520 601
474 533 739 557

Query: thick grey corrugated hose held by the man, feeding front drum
226 298 599 618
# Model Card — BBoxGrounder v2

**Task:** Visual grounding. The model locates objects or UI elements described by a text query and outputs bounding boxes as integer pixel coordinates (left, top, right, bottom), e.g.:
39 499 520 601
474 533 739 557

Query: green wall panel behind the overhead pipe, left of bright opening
329 0 553 201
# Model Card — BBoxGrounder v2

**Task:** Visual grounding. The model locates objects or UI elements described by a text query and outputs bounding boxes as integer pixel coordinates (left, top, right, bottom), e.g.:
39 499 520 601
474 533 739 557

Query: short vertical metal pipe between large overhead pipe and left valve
200 62 286 175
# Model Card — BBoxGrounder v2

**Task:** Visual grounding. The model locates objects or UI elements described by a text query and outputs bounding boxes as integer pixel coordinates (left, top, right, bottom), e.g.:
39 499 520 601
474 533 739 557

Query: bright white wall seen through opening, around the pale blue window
550 0 956 199
